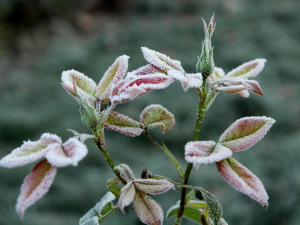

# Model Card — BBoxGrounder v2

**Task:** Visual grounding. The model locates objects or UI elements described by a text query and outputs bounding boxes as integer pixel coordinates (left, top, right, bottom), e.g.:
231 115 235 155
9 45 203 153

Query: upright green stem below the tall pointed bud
174 80 207 225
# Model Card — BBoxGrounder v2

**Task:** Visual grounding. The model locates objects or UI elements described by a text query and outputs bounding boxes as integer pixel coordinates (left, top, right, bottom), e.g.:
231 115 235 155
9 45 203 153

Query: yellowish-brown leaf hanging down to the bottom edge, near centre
133 192 164 225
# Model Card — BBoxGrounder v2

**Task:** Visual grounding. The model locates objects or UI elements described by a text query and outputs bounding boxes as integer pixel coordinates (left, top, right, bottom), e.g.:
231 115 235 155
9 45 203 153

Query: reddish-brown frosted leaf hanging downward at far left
16 160 56 218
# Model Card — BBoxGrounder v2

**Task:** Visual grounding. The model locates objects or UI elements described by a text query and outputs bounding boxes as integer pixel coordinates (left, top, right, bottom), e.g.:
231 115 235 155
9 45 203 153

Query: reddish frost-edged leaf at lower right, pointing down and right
217 157 269 209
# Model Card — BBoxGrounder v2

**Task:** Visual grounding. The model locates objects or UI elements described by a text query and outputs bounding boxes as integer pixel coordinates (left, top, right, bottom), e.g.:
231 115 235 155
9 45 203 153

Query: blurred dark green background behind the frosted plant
0 0 300 225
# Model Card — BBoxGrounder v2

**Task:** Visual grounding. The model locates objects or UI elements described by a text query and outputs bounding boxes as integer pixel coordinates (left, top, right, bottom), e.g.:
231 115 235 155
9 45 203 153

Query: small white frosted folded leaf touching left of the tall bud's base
168 70 203 91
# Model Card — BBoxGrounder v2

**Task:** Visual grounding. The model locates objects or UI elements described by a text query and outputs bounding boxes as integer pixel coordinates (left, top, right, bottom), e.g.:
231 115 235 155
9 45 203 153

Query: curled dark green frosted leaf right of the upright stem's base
193 186 223 224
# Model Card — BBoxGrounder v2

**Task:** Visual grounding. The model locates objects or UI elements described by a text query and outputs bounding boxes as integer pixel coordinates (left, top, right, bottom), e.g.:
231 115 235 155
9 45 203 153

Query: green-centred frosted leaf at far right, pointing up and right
219 116 275 152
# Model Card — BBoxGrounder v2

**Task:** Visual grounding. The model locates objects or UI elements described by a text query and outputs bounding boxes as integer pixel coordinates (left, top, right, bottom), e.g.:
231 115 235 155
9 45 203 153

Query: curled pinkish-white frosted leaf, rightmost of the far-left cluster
45 137 88 167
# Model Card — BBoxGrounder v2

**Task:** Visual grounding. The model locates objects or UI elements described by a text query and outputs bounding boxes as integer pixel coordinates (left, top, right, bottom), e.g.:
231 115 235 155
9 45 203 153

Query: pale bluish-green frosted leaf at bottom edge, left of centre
79 192 116 225
